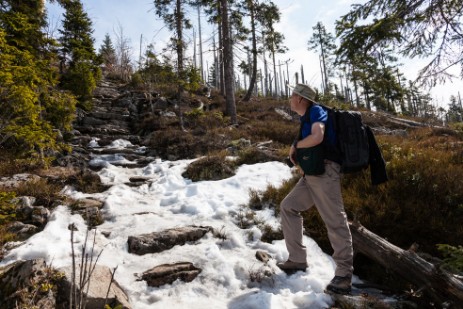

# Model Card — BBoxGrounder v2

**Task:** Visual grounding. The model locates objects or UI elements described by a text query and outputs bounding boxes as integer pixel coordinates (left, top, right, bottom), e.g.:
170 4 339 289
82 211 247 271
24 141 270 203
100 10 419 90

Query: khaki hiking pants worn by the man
280 161 353 276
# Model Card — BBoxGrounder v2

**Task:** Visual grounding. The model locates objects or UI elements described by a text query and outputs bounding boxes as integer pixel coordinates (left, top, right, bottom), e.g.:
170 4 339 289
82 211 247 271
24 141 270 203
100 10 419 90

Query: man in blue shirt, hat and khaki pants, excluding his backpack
277 84 353 294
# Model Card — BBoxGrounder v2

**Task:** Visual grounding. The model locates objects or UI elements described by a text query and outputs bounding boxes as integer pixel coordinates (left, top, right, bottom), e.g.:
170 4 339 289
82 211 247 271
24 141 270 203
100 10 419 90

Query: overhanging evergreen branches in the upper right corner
337 0 463 85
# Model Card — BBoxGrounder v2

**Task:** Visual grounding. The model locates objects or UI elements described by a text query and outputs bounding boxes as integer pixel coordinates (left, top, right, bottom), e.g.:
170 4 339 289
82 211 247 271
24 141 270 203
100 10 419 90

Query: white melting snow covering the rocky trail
0 140 342 309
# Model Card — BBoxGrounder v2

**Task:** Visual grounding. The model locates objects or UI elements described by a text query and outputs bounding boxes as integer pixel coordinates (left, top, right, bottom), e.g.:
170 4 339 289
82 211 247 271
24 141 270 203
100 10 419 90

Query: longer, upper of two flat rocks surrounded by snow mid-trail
128 226 212 255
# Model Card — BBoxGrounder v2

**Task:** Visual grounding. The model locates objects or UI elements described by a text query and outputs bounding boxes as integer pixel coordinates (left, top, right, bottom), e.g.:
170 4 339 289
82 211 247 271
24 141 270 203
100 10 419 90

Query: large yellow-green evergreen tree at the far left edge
0 1 75 163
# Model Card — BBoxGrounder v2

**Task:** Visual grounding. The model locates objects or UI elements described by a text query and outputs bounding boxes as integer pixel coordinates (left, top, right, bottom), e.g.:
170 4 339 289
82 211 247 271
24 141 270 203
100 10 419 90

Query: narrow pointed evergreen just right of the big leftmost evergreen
59 0 101 110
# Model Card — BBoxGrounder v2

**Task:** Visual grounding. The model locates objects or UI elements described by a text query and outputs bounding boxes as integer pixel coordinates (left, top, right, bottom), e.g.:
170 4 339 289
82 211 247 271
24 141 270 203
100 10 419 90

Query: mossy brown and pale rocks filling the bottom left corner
0 259 131 309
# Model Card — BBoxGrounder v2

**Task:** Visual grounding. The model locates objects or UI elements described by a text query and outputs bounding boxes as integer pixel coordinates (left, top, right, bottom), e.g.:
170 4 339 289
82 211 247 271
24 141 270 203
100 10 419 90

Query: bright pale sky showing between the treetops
47 0 463 107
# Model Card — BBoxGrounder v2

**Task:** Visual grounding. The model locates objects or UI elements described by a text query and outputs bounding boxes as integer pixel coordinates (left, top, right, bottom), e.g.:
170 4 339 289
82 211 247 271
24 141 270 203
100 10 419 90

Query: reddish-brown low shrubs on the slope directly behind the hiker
245 128 463 270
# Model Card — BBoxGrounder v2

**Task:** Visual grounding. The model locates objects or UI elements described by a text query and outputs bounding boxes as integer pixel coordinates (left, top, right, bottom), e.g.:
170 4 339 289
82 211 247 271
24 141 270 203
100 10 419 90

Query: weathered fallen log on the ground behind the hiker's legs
349 222 463 308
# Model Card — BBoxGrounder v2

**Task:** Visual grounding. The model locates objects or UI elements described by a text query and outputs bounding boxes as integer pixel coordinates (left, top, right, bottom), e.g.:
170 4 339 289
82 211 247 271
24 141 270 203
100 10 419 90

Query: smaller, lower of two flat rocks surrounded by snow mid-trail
139 262 202 287
